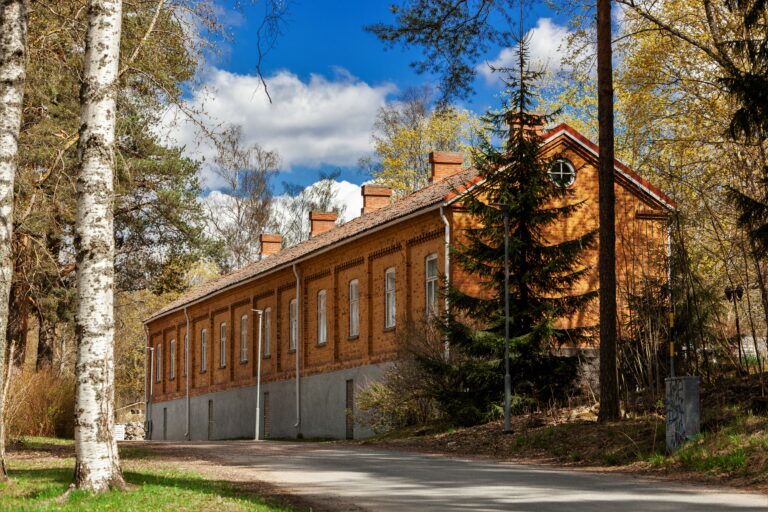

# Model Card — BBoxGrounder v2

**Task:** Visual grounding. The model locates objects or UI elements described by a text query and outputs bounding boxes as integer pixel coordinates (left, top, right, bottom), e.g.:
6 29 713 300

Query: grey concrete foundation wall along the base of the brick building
149 363 387 441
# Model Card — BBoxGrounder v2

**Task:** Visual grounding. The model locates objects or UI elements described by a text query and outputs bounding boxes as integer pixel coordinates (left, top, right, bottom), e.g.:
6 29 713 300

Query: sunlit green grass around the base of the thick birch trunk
0 438 294 512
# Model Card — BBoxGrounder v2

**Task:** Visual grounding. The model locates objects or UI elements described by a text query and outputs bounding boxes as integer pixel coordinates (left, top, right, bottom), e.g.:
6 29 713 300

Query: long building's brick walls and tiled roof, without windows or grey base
147 126 674 402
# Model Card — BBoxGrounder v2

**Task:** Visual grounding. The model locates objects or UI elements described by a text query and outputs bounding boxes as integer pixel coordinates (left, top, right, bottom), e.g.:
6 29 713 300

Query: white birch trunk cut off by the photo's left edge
0 0 28 479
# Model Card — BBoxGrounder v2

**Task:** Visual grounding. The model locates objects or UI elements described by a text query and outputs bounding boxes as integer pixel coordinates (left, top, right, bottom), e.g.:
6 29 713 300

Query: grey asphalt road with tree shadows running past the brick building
148 441 768 512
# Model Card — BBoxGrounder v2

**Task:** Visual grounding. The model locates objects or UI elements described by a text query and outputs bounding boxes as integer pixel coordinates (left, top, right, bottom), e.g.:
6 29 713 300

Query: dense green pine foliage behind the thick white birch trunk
12 0 220 363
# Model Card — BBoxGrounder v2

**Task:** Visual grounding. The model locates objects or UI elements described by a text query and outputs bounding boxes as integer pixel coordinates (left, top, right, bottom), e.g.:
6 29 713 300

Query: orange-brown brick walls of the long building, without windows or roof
149 132 666 401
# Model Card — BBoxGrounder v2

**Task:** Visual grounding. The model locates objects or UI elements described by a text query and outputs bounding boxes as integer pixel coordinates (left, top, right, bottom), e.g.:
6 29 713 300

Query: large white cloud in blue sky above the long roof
161 69 396 188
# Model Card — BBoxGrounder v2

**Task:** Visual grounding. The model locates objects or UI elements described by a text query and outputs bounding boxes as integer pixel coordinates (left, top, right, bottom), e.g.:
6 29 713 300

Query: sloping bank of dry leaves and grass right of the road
359 372 768 493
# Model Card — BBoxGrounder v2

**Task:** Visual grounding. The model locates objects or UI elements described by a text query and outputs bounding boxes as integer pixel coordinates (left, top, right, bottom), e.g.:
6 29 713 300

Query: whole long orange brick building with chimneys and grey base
146 124 675 439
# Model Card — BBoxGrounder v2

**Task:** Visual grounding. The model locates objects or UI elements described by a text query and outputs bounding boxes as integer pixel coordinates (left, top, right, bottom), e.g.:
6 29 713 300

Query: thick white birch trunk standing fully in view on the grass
74 0 125 492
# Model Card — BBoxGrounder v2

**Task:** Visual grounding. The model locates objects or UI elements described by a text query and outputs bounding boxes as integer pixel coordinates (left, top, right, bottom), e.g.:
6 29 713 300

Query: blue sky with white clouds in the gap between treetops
165 0 580 198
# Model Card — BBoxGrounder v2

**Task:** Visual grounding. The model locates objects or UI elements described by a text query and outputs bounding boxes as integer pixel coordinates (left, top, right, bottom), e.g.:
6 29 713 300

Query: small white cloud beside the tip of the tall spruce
477 18 569 84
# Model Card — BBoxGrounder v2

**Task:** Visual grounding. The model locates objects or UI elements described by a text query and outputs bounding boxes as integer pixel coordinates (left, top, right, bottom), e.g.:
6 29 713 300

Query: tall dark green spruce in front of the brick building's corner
420 38 597 424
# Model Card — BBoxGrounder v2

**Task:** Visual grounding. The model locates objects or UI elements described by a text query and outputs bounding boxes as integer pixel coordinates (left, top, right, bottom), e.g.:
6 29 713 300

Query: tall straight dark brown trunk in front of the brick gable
597 0 619 421
